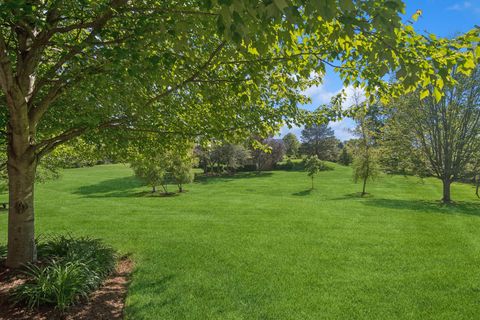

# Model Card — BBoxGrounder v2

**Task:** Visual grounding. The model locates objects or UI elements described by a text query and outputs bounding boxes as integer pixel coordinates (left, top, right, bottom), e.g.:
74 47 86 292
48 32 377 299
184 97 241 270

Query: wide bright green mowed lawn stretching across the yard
0 165 480 320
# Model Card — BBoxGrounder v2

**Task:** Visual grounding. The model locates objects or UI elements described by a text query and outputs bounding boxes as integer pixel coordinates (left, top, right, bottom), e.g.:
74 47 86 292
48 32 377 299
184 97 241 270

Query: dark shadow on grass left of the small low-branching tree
73 176 143 198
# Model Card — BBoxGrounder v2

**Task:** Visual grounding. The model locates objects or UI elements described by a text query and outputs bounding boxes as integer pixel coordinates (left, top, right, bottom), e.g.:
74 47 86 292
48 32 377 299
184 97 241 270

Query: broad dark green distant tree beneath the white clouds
302 124 339 161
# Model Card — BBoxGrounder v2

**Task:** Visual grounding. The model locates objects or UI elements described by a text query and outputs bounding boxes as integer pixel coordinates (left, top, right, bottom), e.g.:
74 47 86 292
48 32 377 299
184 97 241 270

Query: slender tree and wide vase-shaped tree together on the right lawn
341 69 480 203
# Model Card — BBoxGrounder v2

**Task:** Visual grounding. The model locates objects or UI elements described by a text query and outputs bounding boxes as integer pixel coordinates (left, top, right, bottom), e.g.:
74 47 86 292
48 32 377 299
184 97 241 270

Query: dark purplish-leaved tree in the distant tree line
251 138 285 171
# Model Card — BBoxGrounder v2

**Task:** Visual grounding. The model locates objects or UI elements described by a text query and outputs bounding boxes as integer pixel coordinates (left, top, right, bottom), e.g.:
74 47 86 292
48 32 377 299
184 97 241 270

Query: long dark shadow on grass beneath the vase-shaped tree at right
362 199 480 216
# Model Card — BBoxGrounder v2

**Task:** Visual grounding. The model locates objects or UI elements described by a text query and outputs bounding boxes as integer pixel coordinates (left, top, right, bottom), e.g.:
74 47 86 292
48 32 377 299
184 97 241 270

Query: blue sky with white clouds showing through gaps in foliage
280 0 480 140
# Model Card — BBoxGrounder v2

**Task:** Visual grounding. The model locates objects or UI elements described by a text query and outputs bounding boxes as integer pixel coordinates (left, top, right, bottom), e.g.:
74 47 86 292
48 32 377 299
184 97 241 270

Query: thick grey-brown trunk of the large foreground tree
6 133 37 268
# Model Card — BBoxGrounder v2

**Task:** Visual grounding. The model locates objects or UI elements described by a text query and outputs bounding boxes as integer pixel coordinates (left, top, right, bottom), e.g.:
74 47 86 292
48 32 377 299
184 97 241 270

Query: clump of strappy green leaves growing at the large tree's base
13 236 115 311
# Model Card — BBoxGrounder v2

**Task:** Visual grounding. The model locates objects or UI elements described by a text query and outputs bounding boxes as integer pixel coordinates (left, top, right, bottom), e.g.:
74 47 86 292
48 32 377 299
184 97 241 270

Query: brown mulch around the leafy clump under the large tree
0 257 133 320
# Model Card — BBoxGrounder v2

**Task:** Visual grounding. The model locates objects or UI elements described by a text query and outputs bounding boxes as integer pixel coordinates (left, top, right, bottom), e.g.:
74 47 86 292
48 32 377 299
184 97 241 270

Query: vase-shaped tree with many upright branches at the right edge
386 68 480 203
